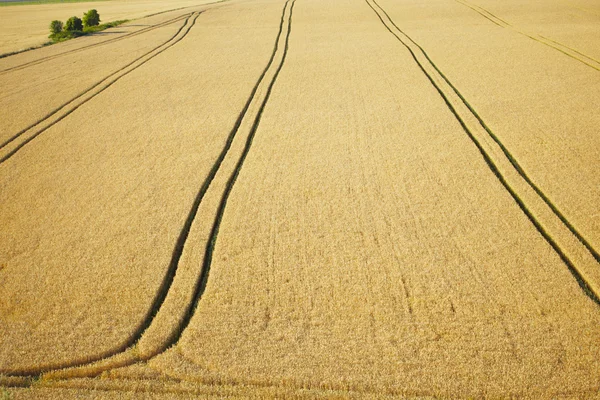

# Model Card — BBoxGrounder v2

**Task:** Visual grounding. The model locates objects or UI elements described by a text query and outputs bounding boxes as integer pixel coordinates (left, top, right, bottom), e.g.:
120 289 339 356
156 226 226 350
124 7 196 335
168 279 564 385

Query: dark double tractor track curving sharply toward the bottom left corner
4 0 295 378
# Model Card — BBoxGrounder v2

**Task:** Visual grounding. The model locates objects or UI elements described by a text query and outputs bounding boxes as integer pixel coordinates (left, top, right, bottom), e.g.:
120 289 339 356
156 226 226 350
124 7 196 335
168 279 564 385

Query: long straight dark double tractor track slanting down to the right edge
365 0 600 305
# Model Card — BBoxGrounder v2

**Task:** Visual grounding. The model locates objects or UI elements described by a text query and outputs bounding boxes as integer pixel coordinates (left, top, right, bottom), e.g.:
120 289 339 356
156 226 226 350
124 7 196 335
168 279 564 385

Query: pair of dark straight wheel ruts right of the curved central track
365 0 600 305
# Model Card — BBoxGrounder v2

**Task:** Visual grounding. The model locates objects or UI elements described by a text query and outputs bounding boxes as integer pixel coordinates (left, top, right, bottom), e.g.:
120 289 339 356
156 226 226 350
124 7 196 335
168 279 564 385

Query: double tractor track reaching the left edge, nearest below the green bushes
0 11 202 165
